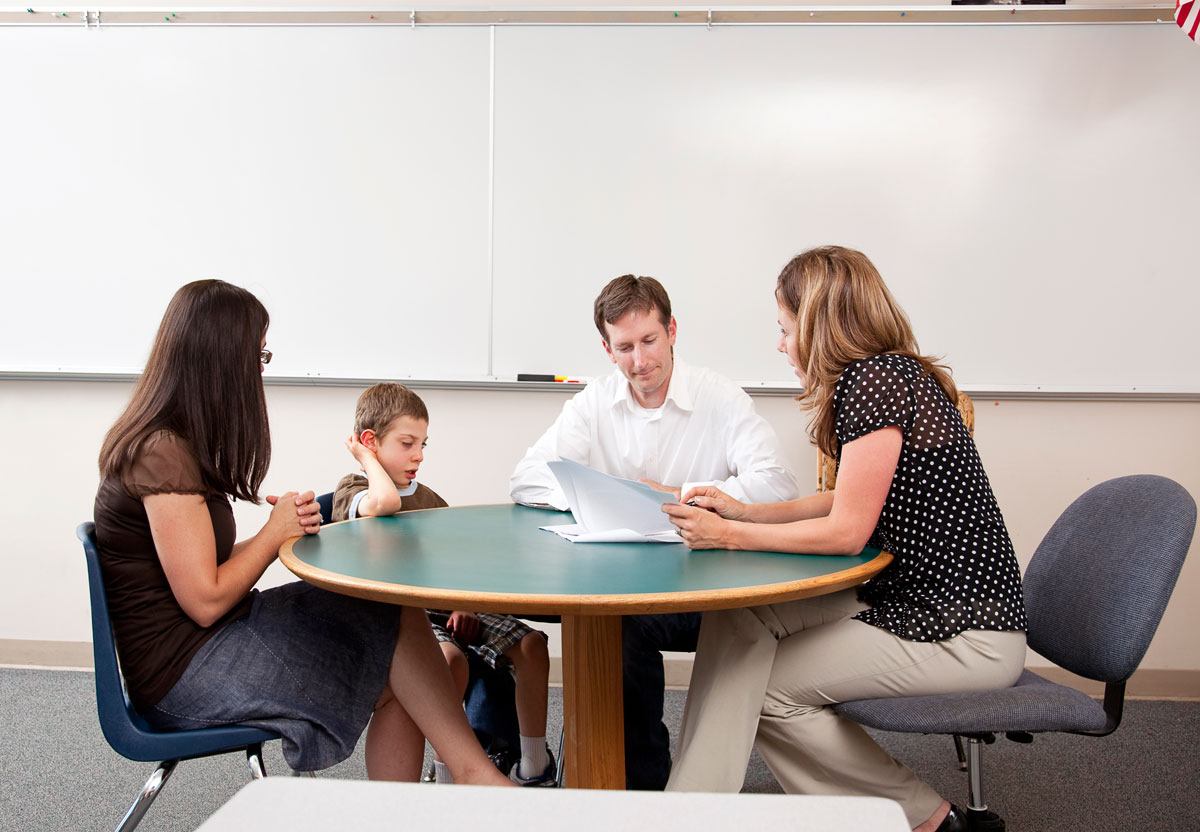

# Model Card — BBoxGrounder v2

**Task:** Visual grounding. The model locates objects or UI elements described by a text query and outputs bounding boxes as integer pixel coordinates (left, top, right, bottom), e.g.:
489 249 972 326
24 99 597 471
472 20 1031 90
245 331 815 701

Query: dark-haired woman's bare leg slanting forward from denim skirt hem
388 606 512 785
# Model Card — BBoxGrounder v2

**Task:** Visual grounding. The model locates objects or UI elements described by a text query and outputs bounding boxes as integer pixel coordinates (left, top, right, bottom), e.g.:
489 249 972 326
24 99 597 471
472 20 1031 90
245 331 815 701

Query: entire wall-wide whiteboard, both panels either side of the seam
0 24 1200 393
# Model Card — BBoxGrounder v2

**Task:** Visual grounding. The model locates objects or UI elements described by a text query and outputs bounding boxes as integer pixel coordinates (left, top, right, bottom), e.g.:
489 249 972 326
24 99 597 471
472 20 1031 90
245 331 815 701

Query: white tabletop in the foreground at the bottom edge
197 777 908 832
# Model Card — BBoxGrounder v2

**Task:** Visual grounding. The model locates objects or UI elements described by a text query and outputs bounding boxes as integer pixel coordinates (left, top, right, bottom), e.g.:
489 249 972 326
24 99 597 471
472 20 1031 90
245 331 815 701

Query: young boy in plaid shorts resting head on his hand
332 382 556 786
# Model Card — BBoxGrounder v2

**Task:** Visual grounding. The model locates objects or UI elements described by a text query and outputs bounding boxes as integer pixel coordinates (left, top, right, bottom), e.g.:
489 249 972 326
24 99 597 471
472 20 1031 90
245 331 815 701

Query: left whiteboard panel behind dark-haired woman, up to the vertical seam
0 26 491 378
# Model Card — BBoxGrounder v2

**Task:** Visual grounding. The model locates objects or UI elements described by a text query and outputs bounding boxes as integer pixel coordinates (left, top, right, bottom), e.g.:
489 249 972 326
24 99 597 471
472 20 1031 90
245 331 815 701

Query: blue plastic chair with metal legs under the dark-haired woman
76 522 278 832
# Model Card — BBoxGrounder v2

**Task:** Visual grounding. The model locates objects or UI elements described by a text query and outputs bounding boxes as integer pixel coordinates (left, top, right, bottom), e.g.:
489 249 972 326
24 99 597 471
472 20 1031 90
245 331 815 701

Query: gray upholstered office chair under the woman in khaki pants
835 474 1196 832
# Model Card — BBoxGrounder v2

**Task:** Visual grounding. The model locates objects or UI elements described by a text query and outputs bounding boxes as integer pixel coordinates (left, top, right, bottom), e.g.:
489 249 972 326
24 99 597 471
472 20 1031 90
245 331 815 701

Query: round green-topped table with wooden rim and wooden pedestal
280 504 892 789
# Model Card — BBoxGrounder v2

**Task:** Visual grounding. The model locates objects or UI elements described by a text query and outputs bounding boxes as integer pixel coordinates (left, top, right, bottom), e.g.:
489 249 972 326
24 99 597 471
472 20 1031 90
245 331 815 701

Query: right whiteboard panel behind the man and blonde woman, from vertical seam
494 25 1200 391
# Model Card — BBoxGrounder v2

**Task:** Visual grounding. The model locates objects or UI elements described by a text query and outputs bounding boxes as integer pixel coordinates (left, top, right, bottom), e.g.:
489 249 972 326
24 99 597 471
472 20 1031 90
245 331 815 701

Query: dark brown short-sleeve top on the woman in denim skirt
94 431 251 712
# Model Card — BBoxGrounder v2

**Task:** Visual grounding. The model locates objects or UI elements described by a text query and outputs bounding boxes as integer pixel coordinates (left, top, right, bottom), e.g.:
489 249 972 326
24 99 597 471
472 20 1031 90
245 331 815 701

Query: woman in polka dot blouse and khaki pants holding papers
664 246 1025 832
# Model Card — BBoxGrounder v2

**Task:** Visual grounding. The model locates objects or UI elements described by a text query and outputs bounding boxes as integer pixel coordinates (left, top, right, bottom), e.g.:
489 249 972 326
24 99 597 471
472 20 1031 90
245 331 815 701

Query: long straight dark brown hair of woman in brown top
100 280 271 503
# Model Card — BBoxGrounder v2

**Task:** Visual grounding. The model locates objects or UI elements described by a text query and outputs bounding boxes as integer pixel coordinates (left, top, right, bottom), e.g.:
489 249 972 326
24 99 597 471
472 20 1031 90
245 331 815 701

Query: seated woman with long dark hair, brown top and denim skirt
95 280 511 785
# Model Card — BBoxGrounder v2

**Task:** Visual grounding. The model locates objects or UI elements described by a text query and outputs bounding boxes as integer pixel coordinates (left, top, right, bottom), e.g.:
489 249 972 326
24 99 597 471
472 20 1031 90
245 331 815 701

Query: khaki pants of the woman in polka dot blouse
667 589 1025 826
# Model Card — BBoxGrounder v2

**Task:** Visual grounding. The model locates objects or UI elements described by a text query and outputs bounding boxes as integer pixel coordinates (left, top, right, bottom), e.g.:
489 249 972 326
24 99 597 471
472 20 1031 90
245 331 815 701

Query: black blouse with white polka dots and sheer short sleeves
834 354 1026 641
